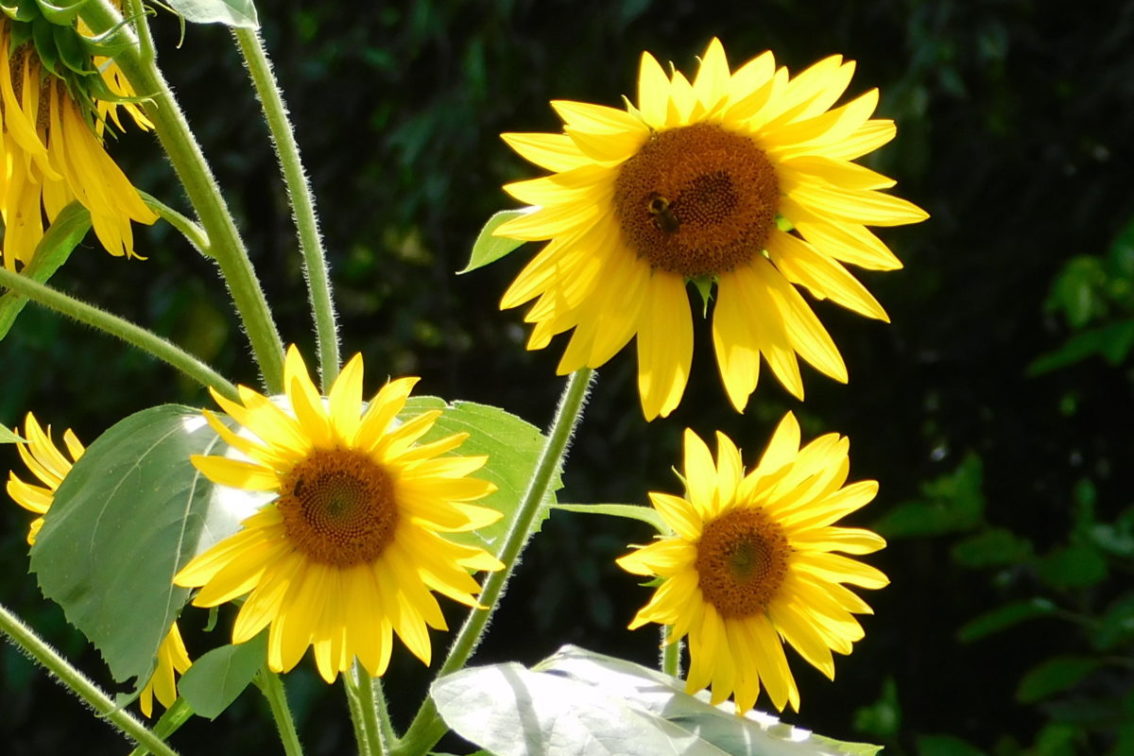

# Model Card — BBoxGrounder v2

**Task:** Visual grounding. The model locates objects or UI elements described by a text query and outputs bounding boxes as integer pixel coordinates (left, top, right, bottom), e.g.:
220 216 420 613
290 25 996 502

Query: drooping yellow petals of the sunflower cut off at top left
0 15 158 270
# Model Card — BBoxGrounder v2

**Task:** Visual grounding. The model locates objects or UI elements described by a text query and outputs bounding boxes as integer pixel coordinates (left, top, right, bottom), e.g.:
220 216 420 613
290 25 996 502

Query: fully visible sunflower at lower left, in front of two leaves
174 347 502 682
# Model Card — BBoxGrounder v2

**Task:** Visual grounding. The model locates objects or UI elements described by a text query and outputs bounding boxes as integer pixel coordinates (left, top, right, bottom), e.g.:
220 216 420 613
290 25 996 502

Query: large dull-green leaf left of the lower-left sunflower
32 405 255 682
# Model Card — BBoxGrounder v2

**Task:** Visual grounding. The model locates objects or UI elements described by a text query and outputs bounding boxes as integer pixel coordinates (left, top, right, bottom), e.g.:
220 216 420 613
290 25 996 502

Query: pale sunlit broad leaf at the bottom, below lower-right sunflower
431 646 880 756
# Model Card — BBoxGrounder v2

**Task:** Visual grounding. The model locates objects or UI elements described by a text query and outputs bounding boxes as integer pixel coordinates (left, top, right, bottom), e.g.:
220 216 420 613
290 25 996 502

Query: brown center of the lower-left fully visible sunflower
278 449 398 567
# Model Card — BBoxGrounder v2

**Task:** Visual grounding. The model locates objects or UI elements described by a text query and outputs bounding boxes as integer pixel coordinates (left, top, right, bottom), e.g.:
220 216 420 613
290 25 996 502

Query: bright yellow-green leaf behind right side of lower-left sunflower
399 397 562 557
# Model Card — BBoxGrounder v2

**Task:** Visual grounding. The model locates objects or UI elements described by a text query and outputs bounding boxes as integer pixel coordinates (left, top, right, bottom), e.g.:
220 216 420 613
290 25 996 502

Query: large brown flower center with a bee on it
615 124 779 277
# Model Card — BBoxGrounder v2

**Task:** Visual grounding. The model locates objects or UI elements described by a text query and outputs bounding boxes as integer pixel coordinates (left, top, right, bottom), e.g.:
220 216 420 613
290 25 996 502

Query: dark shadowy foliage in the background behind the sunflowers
0 0 1134 755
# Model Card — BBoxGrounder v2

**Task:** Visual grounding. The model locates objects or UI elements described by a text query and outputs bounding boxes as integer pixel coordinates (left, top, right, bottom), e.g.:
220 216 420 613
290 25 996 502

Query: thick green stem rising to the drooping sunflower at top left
82 0 284 393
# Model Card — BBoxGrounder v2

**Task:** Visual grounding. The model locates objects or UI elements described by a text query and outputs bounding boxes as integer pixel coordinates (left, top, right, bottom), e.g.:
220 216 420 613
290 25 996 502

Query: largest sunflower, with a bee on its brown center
496 40 926 419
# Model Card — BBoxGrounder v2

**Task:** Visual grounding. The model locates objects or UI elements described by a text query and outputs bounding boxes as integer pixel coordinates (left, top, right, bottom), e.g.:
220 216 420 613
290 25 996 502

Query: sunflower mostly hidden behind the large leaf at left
8 413 192 716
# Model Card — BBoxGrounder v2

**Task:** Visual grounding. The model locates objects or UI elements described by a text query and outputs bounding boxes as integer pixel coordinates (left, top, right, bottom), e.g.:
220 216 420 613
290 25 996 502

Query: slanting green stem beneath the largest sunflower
393 367 594 756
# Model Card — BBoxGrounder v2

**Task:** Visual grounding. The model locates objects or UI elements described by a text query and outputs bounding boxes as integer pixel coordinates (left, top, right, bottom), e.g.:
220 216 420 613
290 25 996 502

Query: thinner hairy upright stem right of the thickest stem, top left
232 28 339 392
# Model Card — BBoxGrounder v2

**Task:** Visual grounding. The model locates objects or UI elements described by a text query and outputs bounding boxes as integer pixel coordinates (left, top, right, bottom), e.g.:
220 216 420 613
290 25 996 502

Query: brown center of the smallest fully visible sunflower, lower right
694 509 792 619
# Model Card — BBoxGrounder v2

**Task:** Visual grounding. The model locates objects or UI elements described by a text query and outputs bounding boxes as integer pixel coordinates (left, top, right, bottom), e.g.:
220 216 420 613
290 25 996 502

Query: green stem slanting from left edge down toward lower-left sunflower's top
0 267 238 400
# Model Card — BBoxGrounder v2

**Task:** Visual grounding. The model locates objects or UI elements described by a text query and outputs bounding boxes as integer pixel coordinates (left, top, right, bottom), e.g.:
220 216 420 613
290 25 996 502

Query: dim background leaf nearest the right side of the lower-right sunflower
872 452 984 538
